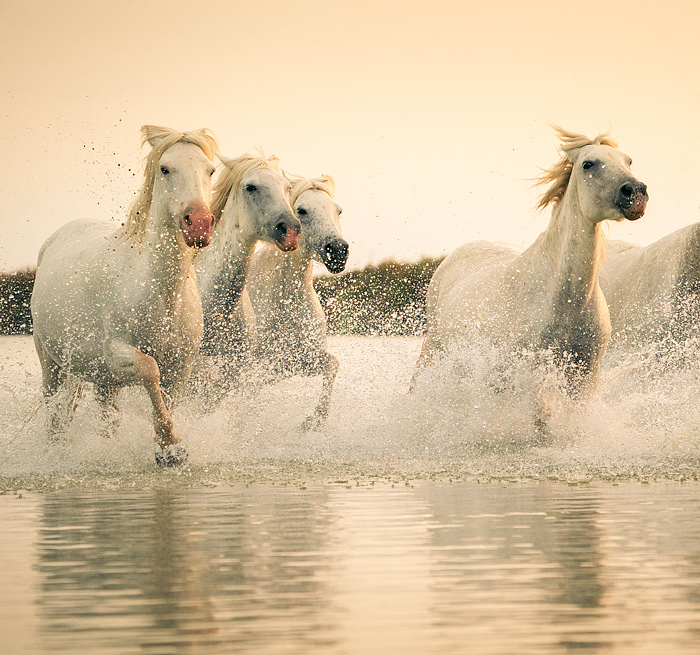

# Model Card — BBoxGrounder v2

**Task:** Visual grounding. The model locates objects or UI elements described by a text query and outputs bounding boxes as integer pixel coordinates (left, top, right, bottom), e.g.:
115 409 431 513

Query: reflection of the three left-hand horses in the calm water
39 487 342 653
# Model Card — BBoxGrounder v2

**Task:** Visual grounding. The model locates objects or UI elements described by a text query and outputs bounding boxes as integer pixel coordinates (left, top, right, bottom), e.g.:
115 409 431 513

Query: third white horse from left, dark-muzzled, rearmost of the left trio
246 175 349 430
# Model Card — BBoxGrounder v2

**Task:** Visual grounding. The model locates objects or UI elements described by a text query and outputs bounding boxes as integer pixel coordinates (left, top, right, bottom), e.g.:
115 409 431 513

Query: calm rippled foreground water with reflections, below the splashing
8 483 700 655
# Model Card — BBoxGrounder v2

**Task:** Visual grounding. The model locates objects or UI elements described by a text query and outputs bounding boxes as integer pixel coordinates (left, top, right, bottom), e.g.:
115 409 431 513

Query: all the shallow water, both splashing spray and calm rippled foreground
0 337 700 654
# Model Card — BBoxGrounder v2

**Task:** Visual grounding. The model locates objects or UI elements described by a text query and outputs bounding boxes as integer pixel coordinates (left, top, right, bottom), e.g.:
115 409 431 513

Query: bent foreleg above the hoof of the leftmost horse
105 341 180 448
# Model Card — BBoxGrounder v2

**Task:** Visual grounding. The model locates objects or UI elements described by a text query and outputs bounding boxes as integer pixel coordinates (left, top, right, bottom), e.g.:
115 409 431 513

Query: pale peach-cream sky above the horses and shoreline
0 0 700 270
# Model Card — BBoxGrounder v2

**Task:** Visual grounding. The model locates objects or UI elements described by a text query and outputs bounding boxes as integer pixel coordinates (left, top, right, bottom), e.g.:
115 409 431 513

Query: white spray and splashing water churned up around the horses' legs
0 337 700 490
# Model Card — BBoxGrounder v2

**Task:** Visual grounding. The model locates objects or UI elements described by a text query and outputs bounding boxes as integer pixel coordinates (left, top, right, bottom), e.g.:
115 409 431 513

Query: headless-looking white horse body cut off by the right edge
601 223 700 348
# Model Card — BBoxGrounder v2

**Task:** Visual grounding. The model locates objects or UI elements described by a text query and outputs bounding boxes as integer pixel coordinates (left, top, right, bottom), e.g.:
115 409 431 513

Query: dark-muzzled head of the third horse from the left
292 175 349 273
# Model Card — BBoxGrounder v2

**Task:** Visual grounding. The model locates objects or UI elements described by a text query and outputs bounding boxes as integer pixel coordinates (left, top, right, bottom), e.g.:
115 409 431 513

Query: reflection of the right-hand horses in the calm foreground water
422 484 700 653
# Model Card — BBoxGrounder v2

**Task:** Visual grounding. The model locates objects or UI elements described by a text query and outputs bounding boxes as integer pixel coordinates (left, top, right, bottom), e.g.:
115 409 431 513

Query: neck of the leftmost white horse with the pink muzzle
144 206 193 307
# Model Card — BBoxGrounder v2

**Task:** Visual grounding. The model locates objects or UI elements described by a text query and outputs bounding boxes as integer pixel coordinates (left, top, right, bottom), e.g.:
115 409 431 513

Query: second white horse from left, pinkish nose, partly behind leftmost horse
197 153 301 396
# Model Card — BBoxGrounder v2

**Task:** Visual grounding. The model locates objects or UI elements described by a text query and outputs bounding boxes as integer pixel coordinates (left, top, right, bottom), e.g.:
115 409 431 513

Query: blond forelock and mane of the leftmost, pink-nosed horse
122 125 219 241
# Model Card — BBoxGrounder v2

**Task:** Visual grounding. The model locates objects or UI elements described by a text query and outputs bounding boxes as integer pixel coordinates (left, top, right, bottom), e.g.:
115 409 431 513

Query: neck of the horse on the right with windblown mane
542 193 605 309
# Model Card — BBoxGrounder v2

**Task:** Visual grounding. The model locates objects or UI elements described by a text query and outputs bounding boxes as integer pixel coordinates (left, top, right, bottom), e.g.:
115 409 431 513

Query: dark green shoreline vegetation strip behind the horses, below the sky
0 258 442 336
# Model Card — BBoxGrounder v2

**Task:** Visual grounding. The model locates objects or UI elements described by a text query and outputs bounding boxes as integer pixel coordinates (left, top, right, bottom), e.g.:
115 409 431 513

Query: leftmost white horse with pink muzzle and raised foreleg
31 125 218 465
